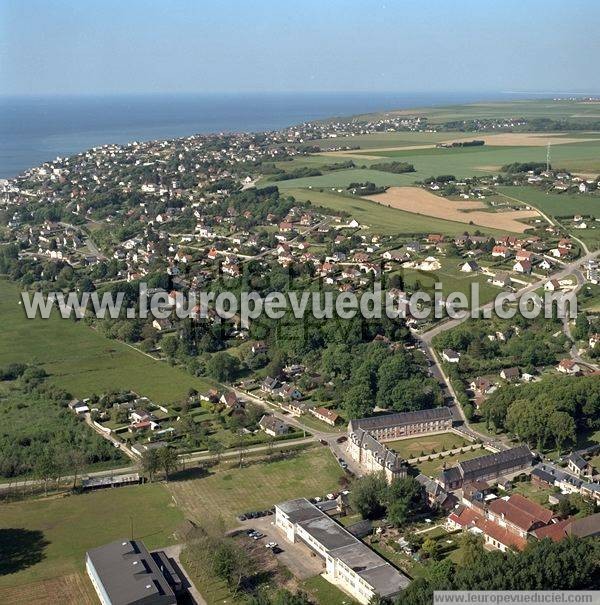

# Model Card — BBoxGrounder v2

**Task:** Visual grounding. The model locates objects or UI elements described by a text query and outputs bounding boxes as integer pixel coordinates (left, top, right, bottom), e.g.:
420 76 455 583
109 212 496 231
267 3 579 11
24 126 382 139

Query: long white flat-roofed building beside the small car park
275 498 409 605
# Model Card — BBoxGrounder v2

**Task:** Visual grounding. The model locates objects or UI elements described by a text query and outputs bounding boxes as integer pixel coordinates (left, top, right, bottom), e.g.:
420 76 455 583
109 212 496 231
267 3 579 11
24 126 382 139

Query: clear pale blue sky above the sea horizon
0 0 600 95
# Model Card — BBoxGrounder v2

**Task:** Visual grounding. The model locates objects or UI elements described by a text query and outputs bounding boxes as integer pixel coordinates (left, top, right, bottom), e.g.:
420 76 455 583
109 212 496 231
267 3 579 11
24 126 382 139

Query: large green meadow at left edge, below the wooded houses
0 280 214 402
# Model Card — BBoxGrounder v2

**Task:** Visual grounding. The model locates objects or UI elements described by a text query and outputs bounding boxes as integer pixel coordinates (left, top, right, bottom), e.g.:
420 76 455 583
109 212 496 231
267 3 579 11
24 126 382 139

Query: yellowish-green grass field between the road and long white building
169 447 342 527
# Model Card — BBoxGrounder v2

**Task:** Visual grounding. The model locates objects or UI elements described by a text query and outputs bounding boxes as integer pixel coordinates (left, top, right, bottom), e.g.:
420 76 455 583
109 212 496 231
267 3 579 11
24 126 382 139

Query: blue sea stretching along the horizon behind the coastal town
0 92 522 178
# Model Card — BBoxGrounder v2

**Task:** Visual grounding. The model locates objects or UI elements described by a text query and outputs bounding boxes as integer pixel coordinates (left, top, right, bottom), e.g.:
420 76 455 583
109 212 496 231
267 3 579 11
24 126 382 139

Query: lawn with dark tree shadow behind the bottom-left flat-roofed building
0 484 183 588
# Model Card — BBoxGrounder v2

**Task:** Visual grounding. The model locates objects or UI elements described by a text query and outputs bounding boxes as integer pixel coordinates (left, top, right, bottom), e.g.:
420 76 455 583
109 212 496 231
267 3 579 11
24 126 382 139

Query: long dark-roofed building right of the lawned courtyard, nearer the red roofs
439 445 533 490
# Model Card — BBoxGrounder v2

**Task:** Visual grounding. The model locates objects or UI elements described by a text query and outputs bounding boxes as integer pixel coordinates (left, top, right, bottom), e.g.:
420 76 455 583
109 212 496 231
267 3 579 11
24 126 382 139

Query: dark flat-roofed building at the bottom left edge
87 540 177 605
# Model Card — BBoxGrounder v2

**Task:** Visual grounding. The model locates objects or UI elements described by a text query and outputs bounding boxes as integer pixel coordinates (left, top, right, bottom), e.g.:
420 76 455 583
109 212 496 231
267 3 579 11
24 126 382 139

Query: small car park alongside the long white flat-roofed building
240 515 325 580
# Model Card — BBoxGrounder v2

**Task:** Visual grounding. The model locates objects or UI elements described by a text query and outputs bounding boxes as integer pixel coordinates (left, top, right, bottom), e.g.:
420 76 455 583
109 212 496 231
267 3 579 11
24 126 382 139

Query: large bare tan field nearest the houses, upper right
367 187 540 233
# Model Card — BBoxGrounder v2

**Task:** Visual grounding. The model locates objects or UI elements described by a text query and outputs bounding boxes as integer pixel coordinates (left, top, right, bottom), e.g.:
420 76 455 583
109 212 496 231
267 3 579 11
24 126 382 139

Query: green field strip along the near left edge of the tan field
278 188 506 235
